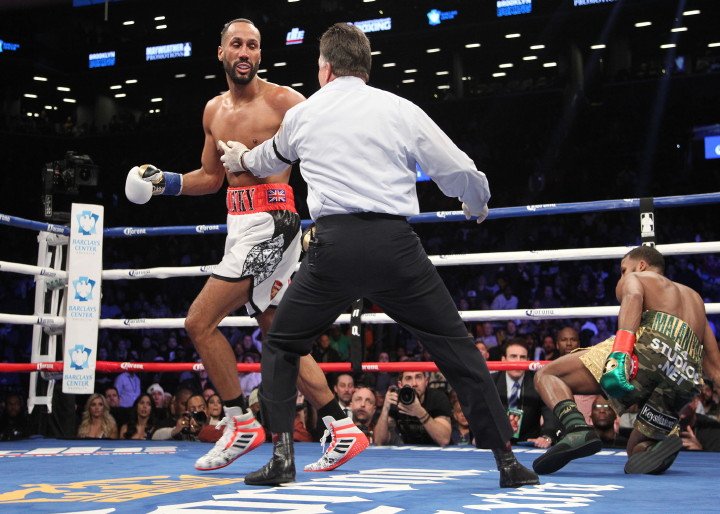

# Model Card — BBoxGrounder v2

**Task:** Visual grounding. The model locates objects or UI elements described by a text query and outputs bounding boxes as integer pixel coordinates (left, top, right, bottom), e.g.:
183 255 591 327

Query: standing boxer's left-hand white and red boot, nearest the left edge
195 407 265 471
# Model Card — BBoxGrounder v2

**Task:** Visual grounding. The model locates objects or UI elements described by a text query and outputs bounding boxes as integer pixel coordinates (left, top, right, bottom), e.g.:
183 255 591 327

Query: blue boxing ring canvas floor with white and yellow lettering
0 439 720 514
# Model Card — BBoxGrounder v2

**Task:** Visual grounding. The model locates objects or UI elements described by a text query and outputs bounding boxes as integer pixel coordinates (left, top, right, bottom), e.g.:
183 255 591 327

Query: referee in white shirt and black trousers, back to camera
220 23 539 487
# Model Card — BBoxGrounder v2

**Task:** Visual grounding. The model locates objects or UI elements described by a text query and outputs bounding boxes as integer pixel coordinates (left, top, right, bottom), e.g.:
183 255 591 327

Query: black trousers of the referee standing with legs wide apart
260 213 512 448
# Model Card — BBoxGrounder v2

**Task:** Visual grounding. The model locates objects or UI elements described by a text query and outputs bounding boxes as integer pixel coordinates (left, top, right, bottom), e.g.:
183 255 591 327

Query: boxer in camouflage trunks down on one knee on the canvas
533 246 720 474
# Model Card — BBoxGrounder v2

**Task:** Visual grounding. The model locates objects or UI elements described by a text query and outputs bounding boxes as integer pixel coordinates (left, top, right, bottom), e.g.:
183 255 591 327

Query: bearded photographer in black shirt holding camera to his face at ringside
374 371 452 446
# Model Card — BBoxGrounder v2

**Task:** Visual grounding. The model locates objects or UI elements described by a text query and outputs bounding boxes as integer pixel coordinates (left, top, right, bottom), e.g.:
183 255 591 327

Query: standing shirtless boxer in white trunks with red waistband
125 18 368 470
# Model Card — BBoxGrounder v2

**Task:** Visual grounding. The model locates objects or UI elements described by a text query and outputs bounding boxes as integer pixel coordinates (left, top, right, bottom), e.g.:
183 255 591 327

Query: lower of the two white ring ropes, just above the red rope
0 303 720 330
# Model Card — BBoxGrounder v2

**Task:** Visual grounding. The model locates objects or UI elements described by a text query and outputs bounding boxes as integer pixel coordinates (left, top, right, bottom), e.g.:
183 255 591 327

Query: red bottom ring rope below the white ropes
0 361 550 373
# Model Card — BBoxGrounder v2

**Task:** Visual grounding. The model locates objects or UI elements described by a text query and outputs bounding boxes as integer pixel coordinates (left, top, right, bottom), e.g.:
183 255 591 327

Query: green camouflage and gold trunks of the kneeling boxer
576 311 703 439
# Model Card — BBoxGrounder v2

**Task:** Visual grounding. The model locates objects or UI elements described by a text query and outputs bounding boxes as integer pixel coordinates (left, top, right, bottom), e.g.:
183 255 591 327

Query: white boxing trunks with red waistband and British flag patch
212 184 301 316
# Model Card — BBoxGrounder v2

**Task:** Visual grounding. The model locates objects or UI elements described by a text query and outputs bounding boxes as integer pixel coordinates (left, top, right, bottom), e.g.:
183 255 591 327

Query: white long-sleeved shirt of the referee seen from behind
244 77 490 220
